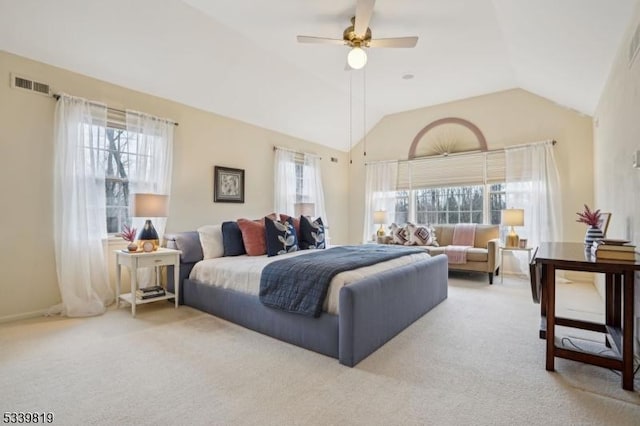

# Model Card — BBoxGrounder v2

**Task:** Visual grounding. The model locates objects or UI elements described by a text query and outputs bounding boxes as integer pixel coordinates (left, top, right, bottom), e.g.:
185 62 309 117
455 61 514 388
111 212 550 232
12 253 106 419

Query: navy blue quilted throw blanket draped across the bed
260 244 424 317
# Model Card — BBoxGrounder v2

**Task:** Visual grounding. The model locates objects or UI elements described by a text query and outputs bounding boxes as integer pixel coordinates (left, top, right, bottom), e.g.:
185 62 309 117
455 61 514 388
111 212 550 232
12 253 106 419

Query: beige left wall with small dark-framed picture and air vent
0 51 348 320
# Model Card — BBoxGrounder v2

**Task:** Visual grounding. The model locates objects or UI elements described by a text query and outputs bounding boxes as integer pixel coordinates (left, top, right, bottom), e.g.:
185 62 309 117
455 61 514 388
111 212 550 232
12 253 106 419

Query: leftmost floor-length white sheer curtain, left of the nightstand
49 94 114 317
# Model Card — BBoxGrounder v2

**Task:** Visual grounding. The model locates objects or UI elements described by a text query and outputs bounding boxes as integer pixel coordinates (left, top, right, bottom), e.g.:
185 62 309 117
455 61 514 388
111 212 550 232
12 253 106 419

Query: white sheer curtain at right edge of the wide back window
505 141 562 271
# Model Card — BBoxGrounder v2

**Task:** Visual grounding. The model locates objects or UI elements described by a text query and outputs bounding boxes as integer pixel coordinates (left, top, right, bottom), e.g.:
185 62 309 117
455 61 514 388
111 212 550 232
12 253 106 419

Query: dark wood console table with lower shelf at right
532 243 640 390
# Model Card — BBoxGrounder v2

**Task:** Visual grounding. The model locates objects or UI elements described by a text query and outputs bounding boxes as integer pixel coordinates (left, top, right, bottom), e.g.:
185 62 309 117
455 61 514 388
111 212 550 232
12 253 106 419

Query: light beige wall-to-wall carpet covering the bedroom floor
0 274 640 425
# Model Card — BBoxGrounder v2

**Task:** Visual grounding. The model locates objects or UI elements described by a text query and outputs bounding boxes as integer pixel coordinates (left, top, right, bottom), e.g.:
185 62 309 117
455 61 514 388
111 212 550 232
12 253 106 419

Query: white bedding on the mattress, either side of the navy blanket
189 250 429 314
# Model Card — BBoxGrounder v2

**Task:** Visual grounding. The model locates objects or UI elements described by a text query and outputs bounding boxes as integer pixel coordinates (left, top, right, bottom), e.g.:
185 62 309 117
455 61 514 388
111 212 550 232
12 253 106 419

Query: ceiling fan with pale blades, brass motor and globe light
298 0 418 69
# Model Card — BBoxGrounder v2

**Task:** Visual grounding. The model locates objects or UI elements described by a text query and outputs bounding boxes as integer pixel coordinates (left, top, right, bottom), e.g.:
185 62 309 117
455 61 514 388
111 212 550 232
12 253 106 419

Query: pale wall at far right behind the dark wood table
594 3 640 332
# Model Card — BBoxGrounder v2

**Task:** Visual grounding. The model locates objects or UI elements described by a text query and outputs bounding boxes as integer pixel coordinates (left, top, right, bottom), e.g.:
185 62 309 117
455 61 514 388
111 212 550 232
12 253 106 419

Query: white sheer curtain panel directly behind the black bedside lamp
126 110 175 287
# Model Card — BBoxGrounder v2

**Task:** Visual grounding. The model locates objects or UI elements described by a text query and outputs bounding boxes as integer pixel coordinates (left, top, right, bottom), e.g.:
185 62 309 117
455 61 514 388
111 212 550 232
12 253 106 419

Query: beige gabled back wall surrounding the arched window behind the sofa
349 89 593 243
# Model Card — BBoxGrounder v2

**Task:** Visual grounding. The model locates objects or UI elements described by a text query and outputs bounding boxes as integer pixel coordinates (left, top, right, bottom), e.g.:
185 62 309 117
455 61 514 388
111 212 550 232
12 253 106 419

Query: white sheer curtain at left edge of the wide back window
362 161 398 242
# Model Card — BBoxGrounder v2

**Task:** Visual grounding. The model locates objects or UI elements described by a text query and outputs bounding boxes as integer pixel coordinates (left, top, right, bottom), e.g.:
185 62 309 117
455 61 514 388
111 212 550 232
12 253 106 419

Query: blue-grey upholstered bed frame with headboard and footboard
165 231 448 367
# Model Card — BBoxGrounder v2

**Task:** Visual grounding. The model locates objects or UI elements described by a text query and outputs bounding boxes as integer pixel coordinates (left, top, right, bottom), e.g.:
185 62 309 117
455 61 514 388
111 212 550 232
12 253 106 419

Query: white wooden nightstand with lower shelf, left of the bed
115 248 182 317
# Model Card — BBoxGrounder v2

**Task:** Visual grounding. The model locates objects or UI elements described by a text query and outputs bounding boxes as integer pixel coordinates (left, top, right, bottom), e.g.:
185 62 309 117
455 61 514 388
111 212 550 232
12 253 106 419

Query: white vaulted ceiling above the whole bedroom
0 0 638 150
